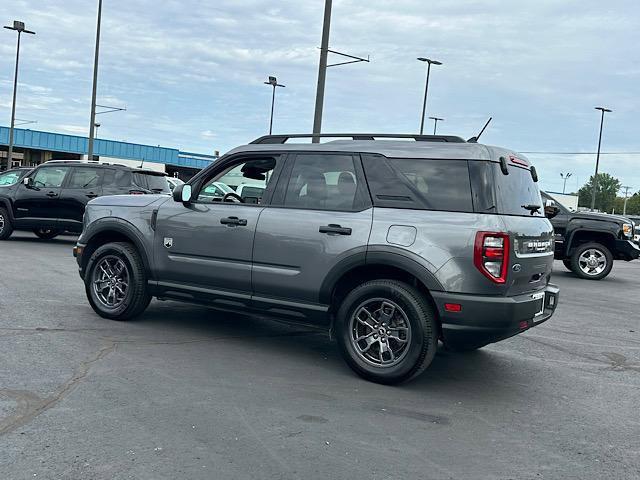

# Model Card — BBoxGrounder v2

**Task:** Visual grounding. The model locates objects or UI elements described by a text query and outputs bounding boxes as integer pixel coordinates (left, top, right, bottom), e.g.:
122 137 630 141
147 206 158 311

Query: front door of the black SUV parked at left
14 165 70 227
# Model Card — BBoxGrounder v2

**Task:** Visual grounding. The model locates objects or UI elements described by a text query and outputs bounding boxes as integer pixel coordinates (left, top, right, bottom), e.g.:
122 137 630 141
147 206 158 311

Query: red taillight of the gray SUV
473 232 509 283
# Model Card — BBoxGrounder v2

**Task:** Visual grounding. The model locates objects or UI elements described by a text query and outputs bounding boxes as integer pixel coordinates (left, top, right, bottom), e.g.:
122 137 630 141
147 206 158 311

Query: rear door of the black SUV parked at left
58 166 104 230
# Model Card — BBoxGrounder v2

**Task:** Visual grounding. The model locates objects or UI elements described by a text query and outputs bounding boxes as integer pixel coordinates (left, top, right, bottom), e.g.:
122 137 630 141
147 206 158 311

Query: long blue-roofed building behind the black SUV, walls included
0 126 218 179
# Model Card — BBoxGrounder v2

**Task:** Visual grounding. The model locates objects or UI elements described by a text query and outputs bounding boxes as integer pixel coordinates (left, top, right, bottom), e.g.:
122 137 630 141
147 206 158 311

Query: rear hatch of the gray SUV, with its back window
492 155 554 296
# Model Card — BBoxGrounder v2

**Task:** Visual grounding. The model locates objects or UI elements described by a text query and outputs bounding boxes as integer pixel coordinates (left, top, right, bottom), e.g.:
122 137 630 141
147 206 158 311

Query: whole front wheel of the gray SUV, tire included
84 242 151 320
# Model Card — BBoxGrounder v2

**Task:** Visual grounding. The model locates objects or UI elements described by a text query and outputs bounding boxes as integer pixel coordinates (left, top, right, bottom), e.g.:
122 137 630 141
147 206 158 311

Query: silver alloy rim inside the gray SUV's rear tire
349 298 411 367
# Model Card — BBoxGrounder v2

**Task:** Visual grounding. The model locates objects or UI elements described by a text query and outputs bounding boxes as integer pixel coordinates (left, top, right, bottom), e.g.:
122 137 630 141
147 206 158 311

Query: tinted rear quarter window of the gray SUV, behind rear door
364 155 473 212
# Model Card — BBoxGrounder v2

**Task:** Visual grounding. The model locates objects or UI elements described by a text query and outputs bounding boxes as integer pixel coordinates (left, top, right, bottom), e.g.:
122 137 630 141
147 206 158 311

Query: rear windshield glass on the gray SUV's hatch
493 163 544 217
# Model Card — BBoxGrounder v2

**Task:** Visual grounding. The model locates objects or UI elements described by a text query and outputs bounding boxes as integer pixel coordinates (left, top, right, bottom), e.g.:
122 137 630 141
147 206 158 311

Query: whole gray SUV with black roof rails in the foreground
74 134 558 384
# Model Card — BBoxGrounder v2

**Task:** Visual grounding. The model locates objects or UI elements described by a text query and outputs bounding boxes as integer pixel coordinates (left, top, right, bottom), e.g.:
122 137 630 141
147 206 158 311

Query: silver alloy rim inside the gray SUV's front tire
92 255 130 309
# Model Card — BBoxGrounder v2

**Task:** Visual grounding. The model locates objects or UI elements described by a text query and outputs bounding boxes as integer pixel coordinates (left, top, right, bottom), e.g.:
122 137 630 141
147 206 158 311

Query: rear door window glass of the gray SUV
284 154 358 210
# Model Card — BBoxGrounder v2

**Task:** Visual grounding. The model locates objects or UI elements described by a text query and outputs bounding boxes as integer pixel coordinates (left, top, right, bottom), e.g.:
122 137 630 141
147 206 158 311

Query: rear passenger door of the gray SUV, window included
252 153 373 315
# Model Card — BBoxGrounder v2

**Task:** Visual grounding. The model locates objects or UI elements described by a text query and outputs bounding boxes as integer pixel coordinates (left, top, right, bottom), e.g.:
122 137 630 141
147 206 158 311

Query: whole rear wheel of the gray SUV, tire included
336 280 438 384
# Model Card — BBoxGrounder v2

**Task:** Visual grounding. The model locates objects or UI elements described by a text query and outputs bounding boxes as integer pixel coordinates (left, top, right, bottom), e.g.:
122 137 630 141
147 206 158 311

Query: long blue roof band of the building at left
0 126 217 168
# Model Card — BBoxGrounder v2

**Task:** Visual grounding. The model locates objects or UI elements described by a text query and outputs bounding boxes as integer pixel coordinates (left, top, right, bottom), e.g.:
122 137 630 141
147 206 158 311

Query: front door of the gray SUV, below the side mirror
154 156 278 305
